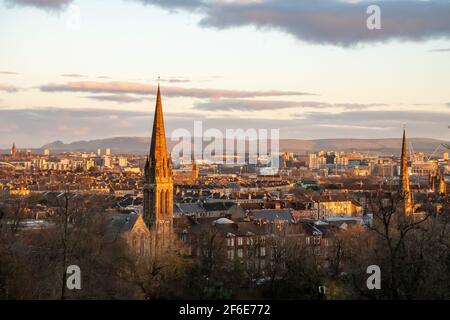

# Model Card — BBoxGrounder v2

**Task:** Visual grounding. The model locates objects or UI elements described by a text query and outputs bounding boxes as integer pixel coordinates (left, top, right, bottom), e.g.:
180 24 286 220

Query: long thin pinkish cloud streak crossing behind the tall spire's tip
40 81 312 98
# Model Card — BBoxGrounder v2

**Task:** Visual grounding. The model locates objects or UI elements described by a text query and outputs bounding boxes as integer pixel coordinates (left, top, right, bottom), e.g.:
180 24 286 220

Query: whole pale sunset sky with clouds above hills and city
0 0 450 148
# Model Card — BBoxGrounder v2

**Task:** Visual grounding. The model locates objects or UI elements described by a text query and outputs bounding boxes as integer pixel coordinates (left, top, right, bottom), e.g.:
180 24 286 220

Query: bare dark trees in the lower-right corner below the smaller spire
340 192 450 299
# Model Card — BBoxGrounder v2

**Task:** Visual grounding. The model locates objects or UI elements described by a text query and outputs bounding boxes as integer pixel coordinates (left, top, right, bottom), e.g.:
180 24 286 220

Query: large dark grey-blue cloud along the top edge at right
136 0 450 46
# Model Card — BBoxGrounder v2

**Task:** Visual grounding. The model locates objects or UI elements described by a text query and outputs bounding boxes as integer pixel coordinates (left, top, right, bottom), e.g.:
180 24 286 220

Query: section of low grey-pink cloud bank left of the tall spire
0 107 152 147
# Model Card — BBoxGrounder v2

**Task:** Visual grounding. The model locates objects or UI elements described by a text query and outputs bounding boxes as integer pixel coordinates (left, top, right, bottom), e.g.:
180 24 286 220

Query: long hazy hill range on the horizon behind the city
35 137 445 154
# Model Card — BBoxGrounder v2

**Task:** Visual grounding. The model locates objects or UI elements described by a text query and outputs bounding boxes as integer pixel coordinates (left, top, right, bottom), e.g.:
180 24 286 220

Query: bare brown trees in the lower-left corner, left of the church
0 194 139 299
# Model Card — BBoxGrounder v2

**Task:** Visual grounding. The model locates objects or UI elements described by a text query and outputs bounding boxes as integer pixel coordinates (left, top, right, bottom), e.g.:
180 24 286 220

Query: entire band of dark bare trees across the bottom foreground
0 193 450 299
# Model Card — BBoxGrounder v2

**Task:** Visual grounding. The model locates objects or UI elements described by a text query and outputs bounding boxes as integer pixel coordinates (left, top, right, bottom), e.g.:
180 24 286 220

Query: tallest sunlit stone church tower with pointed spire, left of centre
144 84 173 235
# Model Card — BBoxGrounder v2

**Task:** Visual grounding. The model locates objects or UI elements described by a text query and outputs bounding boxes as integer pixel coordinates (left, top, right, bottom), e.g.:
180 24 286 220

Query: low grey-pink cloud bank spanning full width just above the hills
0 107 450 147
